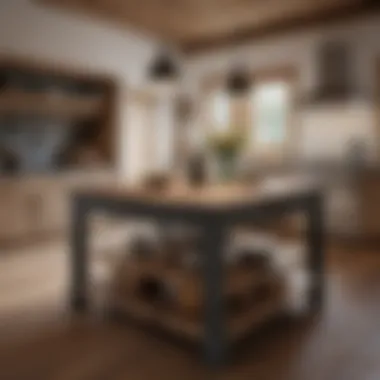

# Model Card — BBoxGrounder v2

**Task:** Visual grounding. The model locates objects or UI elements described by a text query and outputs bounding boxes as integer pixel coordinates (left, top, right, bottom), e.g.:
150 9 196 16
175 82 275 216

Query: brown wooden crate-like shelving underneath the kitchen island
109 257 285 341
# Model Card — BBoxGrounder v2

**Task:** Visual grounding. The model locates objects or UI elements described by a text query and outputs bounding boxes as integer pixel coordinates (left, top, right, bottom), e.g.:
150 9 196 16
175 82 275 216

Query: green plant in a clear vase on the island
209 128 244 180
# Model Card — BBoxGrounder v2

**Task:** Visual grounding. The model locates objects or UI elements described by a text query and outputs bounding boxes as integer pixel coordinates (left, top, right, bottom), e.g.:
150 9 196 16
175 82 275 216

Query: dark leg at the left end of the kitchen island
70 198 89 312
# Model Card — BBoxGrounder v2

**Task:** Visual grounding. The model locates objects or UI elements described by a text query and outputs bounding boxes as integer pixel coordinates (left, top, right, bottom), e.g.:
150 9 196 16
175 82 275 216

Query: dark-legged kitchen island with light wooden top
70 183 325 365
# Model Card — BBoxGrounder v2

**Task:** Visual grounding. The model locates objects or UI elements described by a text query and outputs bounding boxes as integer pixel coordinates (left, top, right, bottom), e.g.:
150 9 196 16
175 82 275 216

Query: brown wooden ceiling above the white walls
39 0 380 52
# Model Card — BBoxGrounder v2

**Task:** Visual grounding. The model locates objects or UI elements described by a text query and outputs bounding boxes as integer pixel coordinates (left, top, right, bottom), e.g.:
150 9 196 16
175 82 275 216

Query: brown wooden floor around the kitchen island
0 242 380 380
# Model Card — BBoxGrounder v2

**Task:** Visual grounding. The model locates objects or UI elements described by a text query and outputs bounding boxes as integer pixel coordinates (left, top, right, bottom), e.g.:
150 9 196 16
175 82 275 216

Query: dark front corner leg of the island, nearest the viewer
200 224 227 367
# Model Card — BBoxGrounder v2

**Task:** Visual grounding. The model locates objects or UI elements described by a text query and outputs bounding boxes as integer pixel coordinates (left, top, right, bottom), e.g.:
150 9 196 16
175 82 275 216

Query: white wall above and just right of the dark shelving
0 0 177 180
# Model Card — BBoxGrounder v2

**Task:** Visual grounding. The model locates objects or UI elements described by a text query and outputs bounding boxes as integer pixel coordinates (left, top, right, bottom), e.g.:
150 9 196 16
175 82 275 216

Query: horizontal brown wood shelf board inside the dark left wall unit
0 91 104 119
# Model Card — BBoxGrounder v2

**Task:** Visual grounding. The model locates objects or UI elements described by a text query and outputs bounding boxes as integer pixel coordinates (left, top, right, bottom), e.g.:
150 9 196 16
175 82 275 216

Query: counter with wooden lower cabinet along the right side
240 161 380 242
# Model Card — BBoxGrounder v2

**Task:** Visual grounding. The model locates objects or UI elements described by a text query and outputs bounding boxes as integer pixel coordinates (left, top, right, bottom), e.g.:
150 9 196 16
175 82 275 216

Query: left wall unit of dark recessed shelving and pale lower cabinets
0 56 117 247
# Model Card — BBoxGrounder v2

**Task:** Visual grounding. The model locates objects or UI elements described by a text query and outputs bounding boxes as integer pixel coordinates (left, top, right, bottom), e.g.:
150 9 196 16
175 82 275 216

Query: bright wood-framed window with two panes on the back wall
207 68 295 157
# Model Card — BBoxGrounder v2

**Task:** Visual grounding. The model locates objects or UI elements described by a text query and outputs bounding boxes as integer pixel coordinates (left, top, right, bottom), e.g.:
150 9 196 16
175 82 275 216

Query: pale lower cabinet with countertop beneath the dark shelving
0 172 116 248
